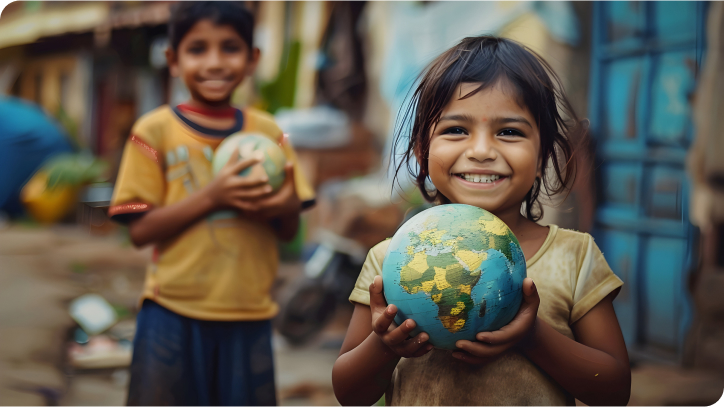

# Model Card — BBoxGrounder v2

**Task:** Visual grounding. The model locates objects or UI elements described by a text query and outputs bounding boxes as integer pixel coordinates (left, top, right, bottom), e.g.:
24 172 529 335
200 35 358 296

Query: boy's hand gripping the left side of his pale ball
206 148 272 209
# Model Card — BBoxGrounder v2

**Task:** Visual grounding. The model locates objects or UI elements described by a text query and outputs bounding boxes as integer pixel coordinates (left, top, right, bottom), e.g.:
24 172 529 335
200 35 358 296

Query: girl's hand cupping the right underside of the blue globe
453 278 540 364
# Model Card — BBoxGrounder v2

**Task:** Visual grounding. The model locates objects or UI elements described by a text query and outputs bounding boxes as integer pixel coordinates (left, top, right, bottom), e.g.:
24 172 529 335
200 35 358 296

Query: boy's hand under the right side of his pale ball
238 162 302 220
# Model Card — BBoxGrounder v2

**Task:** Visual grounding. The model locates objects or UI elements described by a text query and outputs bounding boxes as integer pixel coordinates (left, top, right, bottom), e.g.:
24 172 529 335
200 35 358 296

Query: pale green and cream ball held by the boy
211 132 287 191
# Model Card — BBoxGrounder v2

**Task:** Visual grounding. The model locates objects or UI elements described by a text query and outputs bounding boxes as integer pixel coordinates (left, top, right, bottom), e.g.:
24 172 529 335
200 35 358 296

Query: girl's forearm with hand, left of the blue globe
332 276 432 405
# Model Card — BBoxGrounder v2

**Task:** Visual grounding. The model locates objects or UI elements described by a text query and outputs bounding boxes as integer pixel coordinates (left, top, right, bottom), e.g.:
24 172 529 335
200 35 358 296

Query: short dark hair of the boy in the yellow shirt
168 1 254 51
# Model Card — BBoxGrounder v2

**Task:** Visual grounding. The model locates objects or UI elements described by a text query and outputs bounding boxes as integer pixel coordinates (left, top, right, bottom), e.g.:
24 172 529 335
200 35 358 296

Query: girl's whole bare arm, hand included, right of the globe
453 279 631 405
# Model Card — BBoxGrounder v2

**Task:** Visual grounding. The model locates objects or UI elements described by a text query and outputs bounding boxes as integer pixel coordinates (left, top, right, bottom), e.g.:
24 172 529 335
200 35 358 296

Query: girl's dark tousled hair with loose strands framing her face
393 35 587 221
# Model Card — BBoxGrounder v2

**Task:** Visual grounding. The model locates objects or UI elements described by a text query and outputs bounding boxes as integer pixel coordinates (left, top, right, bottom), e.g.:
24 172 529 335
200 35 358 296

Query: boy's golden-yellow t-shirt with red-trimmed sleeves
109 106 314 321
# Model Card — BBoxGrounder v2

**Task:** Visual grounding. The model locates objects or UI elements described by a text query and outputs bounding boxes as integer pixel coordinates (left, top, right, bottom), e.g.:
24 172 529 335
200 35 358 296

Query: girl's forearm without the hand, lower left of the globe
332 332 400 406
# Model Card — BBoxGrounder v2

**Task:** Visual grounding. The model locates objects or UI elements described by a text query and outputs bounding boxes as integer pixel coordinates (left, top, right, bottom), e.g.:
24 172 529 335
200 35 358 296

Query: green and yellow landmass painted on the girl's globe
400 213 518 333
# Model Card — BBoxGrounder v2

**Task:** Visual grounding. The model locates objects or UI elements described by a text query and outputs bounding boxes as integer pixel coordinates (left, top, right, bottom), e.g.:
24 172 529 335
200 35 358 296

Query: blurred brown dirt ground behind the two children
0 224 724 405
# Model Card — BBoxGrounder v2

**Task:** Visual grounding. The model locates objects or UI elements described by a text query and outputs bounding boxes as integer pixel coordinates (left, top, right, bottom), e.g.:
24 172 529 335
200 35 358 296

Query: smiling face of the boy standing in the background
166 20 259 106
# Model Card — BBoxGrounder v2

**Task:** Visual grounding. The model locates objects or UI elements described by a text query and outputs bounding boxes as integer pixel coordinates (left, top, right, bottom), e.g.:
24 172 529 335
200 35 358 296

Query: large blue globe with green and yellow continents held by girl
382 204 526 349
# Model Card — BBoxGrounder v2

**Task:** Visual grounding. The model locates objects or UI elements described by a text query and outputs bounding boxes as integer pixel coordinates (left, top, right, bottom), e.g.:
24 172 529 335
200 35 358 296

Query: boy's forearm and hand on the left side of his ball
128 154 271 247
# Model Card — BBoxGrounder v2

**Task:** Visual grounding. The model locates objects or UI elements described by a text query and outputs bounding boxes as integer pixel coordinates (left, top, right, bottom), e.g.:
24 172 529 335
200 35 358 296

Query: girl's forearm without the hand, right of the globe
521 318 631 405
